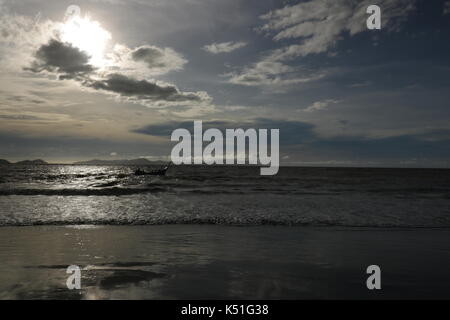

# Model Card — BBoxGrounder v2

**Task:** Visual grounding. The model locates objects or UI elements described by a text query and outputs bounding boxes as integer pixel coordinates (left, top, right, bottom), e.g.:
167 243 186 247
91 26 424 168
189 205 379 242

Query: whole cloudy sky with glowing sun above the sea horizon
0 0 450 167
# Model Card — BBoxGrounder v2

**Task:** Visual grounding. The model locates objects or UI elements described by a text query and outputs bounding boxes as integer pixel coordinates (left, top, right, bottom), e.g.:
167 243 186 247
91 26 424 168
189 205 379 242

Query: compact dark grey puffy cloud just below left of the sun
27 39 94 79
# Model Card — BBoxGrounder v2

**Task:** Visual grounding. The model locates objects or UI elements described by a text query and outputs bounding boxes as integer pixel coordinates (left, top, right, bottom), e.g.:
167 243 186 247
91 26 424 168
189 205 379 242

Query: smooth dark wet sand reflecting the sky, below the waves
0 225 450 299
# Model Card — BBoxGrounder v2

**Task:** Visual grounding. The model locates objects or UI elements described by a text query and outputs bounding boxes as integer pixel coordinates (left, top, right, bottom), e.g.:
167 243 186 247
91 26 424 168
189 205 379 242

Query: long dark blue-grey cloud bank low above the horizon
132 118 450 160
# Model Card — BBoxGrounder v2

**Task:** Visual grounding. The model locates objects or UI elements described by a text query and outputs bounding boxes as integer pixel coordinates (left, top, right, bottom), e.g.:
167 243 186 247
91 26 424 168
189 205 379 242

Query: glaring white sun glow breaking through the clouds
61 15 111 67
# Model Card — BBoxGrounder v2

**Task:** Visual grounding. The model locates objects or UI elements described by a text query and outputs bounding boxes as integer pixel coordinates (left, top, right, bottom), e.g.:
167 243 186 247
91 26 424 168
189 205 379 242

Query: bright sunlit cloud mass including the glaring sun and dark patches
0 6 211 108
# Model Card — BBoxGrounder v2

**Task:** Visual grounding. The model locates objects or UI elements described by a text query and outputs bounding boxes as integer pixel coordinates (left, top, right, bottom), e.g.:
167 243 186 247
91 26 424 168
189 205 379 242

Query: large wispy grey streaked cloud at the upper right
227 0 415 86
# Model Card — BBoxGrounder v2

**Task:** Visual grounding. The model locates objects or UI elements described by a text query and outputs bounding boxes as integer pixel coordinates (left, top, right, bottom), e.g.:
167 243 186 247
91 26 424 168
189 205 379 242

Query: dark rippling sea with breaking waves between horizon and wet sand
0 165 450 228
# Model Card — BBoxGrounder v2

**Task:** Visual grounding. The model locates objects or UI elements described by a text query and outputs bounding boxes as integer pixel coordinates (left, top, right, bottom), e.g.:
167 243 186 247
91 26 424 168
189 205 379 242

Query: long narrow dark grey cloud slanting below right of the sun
84 73 207 102
